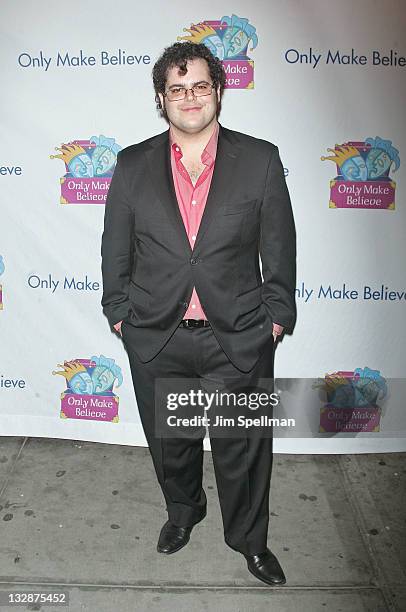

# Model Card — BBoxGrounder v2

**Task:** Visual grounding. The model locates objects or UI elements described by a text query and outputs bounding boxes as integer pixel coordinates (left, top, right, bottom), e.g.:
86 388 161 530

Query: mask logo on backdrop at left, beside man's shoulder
50 135 121 204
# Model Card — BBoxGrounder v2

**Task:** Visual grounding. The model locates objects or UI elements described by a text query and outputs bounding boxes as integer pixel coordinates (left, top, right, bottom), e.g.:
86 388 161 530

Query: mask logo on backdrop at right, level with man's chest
321 136 400 210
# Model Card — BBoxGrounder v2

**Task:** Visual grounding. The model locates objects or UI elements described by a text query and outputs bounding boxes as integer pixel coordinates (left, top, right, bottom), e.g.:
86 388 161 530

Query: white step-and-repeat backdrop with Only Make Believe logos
0 0 406 453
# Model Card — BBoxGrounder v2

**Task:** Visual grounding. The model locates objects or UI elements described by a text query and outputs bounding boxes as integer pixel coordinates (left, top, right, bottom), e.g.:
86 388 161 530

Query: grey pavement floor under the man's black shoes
0 437 406 612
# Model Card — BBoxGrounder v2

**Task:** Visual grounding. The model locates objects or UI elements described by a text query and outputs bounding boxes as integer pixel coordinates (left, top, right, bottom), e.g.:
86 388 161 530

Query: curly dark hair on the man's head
152 42 226 119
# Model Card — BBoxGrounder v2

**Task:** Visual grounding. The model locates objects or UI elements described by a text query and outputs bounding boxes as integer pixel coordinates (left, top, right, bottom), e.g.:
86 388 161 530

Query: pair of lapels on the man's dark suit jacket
146 125 240 253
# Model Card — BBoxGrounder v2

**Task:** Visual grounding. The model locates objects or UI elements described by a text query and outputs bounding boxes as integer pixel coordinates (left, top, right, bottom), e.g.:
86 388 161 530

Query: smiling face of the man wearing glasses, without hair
159 58 220 134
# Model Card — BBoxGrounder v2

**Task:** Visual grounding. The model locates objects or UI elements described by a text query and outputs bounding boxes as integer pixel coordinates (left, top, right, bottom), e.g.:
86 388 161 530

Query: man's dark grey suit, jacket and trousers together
102 126 296 554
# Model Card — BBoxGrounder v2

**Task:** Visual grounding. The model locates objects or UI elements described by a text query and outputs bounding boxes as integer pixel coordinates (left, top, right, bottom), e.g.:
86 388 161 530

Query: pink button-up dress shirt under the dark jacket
169 123 219 319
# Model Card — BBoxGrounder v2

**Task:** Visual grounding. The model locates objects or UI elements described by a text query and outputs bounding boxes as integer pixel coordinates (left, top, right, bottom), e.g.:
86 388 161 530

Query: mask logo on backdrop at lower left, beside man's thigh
52 355 123 423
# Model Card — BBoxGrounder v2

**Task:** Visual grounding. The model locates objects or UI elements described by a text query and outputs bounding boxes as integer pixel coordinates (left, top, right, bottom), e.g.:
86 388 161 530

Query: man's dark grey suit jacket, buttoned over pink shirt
102 126 296 372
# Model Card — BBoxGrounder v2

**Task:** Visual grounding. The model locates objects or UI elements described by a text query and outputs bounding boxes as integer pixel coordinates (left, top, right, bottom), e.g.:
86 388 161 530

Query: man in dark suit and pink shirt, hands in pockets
102 42 296 584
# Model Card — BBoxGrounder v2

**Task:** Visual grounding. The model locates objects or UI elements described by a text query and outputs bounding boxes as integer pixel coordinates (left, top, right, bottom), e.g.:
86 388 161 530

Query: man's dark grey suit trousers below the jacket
122 321 274 554
